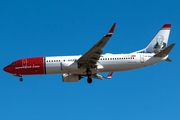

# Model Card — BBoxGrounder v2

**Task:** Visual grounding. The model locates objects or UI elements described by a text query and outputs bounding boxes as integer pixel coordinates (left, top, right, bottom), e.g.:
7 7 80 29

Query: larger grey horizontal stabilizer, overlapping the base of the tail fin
154 43 175 57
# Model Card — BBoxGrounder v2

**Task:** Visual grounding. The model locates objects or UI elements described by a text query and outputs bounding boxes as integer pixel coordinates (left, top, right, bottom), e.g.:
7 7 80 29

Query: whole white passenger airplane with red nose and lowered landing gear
3 23 175 83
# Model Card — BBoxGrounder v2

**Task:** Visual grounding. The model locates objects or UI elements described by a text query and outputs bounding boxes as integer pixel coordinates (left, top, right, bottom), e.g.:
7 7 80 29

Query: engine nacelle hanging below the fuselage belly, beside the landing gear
62 74 81 82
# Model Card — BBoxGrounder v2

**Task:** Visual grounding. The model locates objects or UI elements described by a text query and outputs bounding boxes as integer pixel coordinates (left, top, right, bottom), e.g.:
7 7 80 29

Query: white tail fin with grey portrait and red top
136 24 171 53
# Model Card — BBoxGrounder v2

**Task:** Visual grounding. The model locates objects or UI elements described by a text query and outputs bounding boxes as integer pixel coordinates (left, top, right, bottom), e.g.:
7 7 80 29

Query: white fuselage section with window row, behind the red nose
45 53 164 75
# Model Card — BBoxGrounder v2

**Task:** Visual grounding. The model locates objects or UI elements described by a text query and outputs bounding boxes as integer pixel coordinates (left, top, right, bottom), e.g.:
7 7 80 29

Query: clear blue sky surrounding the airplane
0 0 180 120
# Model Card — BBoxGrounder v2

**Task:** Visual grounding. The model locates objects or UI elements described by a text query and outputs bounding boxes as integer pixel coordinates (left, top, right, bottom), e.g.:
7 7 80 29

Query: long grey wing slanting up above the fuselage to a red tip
77 23 116 68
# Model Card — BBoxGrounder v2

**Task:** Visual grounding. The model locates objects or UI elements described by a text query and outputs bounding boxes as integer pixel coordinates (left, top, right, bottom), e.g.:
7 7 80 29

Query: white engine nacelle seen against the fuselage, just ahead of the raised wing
61 62 78 70
